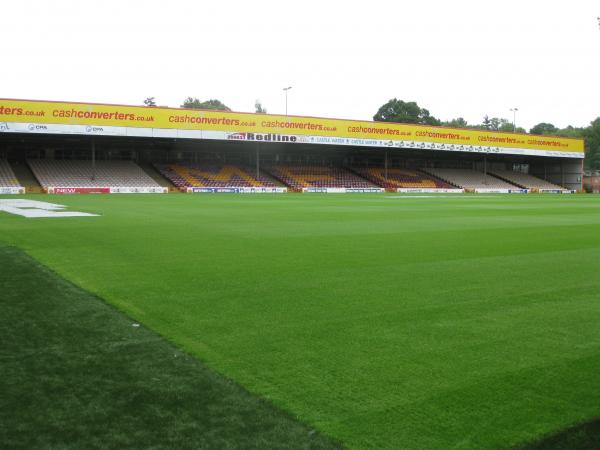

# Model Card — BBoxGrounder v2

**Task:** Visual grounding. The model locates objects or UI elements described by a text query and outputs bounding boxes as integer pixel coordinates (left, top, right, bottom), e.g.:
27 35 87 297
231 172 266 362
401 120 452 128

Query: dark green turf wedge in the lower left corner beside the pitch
0 244 337 450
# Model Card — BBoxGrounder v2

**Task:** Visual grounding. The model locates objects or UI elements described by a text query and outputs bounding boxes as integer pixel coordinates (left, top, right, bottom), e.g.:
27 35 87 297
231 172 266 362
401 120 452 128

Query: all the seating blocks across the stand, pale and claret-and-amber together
0 160 562 190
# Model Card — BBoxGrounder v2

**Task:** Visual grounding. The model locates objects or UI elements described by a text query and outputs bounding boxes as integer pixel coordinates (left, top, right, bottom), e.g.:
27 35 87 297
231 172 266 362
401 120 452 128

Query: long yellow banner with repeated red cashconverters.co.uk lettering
0 99 584 157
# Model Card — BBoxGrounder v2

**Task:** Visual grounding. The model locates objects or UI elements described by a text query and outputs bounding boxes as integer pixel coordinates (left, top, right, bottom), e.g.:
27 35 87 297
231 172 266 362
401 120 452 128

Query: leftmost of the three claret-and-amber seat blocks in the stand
155 164 280 188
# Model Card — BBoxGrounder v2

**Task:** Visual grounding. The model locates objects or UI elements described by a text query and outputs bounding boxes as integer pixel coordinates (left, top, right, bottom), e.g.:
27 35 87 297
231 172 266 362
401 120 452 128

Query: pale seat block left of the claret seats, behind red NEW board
27 159 159 189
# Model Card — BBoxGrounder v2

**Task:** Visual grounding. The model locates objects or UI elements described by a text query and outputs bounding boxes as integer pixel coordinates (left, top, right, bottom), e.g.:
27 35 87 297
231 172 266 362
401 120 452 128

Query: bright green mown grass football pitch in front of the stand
0 194 600 450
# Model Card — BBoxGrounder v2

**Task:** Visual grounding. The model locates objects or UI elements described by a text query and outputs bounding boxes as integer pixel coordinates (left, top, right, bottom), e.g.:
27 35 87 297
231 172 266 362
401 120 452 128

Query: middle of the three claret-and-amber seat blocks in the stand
269 165 379 191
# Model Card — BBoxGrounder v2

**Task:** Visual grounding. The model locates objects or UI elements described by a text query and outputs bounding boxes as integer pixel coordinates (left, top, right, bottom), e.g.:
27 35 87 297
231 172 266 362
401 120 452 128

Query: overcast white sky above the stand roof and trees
0 0 600 129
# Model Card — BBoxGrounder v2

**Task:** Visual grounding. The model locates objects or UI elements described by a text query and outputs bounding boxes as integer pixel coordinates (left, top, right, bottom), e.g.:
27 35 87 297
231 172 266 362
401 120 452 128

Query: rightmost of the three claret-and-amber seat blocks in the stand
352 167 455 190
